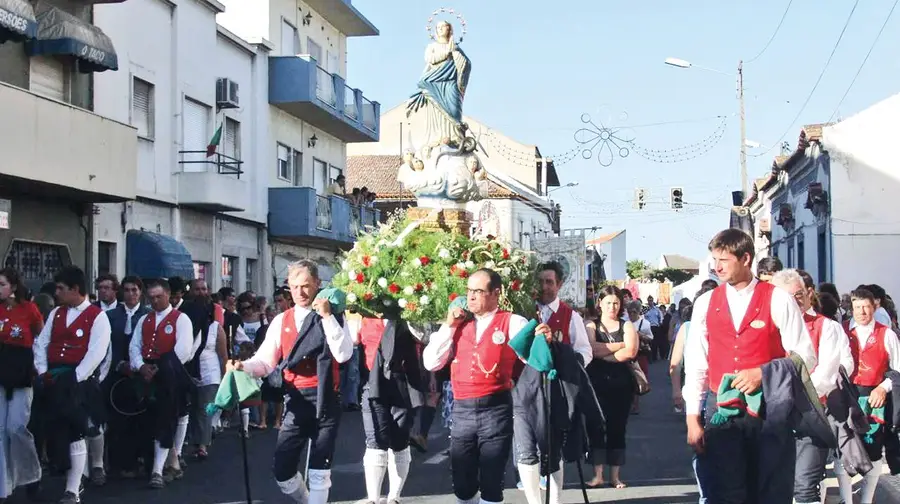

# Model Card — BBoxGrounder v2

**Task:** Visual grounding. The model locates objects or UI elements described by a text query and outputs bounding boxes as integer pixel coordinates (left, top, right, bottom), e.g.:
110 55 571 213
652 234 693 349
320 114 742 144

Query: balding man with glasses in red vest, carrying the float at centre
422 268 543 504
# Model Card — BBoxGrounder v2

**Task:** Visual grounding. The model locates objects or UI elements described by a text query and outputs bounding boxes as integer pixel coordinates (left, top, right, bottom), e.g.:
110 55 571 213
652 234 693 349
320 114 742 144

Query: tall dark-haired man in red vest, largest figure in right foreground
682 229 816 504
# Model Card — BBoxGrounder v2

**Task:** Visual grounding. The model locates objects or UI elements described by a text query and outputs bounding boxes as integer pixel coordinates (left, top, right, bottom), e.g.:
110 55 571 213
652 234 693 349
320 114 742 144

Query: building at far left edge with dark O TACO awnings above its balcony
0 0 137 291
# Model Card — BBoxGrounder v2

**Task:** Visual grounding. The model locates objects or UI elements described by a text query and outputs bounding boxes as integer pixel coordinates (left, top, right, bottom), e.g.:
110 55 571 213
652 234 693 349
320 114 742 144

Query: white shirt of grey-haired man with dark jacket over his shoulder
244 306 353 378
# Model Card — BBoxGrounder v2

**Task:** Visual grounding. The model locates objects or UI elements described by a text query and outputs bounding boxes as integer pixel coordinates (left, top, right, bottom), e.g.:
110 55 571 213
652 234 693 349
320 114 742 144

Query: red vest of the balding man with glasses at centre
450 311 519 399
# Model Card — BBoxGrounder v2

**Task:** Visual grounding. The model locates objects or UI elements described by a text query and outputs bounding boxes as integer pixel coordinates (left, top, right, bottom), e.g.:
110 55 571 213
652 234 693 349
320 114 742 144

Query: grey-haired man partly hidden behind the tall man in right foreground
770 269 855 504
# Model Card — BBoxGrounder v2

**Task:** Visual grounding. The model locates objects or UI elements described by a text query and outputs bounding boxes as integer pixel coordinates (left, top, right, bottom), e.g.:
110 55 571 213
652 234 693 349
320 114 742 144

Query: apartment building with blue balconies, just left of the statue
218 0 380 283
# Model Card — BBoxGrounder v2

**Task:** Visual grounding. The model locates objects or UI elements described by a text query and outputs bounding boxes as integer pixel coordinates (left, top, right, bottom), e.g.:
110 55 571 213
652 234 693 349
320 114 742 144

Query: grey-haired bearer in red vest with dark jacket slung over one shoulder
228 260 353 504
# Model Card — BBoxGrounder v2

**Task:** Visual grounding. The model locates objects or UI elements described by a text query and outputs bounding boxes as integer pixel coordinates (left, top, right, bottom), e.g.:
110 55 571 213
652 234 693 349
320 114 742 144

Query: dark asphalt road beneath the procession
10 363 900 504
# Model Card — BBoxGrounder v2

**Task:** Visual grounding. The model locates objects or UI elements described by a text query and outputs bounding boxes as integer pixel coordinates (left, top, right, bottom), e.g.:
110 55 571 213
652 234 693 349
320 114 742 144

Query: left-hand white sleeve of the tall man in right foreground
681 291 712 415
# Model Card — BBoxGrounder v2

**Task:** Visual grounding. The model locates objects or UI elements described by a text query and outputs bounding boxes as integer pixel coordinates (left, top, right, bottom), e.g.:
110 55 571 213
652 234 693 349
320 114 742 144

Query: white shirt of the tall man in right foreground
681 278 817 415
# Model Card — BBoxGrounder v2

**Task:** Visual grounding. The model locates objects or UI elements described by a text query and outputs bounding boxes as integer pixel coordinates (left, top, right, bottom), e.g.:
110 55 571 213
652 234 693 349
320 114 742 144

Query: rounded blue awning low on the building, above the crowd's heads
125 230 194 280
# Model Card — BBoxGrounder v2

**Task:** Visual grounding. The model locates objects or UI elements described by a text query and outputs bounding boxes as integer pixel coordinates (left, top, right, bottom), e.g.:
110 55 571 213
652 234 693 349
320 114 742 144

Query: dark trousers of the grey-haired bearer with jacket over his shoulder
273 388 341 481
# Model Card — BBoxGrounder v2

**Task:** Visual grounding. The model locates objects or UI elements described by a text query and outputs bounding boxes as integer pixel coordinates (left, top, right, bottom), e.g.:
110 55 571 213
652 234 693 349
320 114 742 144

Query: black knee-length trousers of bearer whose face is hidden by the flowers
362 385 414 452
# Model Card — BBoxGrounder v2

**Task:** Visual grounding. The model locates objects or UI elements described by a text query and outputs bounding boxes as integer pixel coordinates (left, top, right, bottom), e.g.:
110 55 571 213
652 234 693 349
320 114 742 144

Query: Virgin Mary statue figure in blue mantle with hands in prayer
406 21 472 149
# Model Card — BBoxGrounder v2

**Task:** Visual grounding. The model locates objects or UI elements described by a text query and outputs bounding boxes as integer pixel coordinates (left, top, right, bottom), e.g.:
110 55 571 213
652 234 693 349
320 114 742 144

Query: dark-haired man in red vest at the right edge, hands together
834 288 900 504
